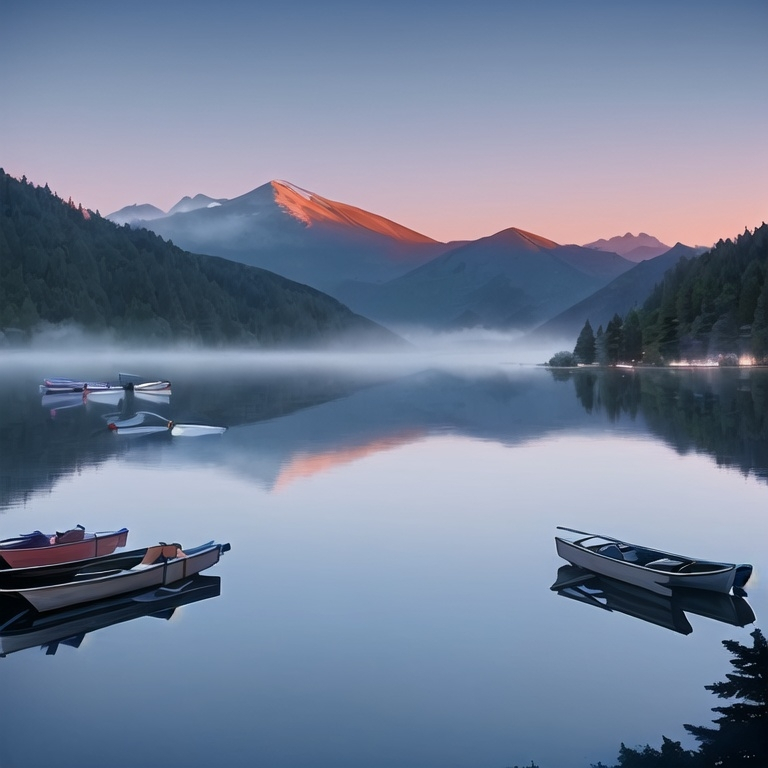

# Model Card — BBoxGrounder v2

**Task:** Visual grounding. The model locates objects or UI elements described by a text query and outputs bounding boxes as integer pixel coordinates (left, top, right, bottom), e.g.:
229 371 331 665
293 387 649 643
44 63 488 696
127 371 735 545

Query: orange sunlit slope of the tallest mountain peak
271 181 437 243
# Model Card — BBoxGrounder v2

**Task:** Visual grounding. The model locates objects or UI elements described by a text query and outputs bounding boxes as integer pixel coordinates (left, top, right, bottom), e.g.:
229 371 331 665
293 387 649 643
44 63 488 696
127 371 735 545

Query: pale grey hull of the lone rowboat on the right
555 536 737 596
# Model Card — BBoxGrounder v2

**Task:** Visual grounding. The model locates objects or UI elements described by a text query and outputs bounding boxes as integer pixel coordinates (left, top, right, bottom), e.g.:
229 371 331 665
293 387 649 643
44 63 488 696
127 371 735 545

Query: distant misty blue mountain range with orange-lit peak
107 181 684 331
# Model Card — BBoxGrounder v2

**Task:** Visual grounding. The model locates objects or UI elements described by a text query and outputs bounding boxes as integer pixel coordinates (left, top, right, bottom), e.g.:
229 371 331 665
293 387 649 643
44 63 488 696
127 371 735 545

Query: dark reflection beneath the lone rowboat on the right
550 565 755 635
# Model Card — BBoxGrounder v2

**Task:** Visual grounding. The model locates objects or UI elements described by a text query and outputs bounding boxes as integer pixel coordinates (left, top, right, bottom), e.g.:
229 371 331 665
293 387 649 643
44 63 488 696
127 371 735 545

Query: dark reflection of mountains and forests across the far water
0 363 768 507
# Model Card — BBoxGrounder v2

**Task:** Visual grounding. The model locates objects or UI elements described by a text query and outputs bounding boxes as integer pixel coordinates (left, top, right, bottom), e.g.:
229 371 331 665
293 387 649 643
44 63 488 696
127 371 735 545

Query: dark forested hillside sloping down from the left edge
0 169 396 346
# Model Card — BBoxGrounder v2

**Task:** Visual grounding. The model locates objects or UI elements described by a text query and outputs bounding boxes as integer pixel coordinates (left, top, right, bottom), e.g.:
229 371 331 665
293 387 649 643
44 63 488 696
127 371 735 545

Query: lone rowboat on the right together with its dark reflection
551 527 755 634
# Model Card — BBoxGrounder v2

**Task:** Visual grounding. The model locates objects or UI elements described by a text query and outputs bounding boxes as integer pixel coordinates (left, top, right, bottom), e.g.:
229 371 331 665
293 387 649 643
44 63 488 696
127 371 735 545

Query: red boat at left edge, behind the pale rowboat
0 525 128 569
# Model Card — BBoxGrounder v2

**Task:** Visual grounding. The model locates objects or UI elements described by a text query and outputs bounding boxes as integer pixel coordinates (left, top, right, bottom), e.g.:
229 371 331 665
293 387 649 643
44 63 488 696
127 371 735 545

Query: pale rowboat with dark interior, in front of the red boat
0 541 230 612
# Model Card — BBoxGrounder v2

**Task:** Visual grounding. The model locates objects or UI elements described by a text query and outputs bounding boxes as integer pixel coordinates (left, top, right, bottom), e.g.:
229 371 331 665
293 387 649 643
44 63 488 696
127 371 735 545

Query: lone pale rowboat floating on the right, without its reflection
555 526 752 596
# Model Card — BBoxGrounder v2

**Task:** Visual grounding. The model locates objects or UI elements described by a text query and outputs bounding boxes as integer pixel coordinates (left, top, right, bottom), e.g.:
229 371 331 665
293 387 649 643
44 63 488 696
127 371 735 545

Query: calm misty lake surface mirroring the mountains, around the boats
0 352 768 768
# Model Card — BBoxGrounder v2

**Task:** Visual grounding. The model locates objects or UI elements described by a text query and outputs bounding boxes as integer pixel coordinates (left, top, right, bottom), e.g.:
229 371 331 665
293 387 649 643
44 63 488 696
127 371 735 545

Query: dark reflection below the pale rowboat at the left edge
0 574 221 657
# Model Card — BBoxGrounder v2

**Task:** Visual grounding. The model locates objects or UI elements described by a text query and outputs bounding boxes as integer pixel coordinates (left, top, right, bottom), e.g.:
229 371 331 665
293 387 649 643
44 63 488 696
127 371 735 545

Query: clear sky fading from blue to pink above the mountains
0 0 768 246
